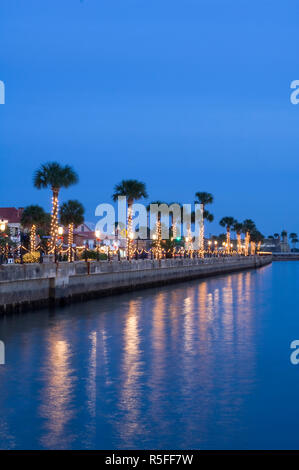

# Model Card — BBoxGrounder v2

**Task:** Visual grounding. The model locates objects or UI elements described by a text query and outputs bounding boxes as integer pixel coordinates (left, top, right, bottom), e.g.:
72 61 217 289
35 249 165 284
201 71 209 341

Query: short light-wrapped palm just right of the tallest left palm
60 200 84 262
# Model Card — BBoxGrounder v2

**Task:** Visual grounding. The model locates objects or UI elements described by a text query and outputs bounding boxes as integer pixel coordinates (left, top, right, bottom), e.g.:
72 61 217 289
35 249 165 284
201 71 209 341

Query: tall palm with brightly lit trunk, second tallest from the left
112 180 148 259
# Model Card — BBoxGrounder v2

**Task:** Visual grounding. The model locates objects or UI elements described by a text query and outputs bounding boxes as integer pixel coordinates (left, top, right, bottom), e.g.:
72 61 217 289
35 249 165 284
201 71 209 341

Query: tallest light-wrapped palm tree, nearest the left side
33 162 78 250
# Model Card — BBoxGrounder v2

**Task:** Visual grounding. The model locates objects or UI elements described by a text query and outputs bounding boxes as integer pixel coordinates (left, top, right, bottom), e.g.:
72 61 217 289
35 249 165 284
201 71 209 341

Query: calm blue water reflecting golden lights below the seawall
0 262 299 449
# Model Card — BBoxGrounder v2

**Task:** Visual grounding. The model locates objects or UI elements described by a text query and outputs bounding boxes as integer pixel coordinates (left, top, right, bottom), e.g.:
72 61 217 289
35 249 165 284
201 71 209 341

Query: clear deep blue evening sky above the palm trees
0 0 299 235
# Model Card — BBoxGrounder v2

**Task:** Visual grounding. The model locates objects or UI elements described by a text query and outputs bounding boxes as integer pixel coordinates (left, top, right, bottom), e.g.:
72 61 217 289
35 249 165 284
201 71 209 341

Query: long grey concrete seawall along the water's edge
0 256 272 314
